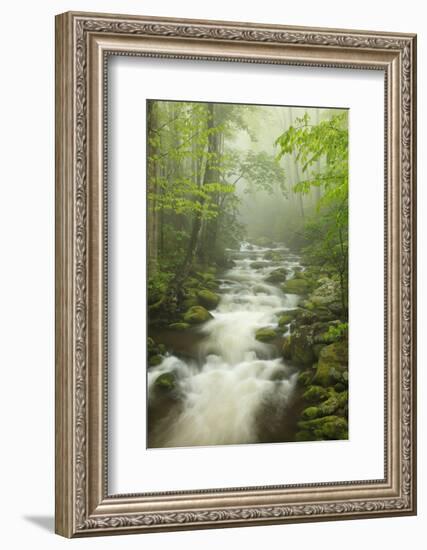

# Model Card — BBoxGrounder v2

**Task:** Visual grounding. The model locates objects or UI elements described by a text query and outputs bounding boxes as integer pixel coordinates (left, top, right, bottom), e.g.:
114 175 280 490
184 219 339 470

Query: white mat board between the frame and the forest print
109 57 384 494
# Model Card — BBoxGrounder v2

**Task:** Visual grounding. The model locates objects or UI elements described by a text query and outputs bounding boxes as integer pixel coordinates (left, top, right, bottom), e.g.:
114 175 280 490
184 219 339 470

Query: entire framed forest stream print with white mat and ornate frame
56 12 416 537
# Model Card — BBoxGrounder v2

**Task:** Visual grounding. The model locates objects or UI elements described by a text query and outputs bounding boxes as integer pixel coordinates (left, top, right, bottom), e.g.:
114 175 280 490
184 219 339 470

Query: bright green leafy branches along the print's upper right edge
276 112 348 312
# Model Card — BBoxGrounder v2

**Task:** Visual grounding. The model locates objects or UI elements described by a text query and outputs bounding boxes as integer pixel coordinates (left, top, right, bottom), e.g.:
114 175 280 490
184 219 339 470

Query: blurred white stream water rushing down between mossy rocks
148 242 299 447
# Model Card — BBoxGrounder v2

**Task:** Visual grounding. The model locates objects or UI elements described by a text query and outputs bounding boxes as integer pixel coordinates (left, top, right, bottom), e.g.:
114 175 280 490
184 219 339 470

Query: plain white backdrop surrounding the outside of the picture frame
0 0 427 550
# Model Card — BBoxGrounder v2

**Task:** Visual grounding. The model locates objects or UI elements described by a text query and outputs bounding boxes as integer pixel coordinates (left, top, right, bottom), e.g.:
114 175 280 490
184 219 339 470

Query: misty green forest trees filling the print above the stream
147 100 348 322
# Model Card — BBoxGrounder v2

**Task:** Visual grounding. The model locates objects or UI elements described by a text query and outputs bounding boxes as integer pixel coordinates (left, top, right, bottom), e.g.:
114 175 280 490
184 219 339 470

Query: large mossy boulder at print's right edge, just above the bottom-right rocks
314 341 348 387
